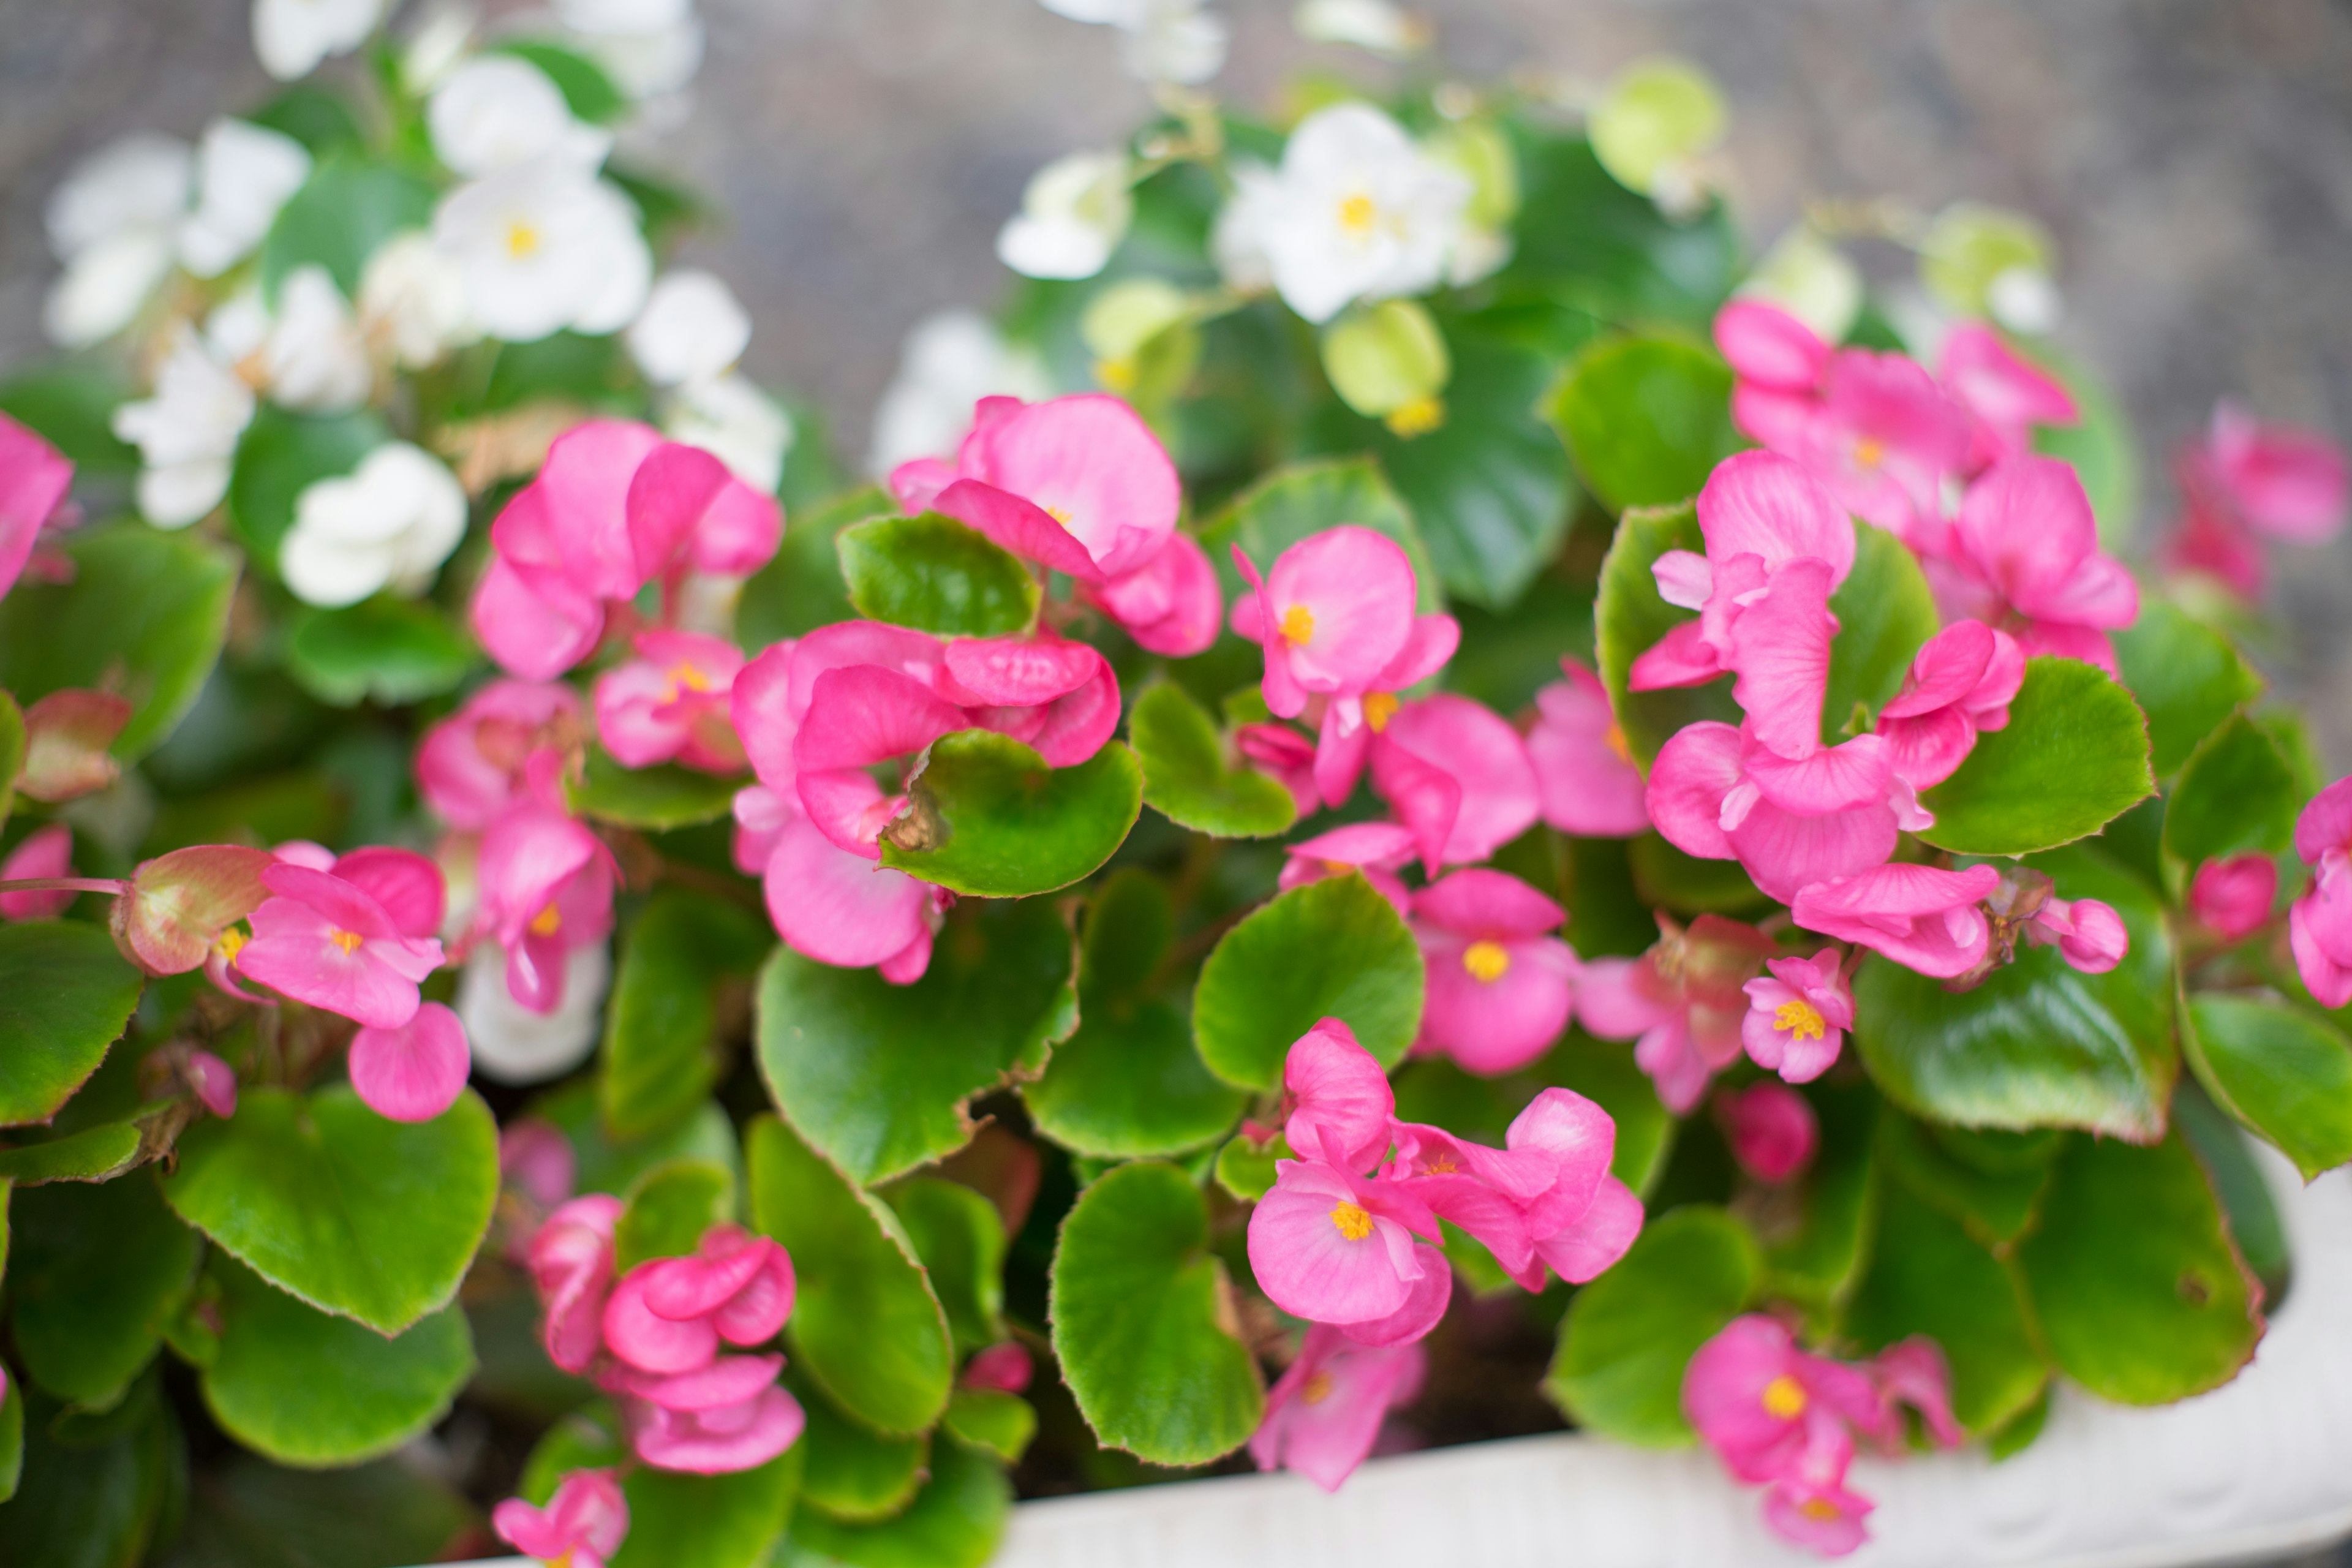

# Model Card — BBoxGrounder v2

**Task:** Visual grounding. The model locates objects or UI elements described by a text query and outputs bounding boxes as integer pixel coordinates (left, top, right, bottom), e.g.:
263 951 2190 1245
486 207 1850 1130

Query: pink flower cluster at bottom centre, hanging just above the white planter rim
1249 1018 1642 1488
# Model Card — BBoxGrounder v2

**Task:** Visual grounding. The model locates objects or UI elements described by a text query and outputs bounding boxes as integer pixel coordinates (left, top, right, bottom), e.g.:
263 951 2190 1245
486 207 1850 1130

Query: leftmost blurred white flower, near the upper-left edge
42 134 195 348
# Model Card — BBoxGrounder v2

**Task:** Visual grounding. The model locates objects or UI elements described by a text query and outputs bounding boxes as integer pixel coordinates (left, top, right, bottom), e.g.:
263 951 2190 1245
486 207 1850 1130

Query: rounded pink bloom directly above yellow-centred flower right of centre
1371 691 1540 875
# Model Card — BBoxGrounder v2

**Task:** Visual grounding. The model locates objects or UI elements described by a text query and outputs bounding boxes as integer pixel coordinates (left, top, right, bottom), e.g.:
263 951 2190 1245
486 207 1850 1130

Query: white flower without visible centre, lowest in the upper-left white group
277 442 466 609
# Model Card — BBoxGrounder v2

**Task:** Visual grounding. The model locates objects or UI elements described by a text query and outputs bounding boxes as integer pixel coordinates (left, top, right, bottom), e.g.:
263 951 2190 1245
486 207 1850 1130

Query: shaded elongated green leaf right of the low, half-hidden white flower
597 886 774 1140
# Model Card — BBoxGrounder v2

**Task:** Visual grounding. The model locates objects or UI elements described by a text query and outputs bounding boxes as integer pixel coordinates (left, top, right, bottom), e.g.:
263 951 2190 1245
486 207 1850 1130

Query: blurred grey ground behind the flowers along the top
0 0 2352 769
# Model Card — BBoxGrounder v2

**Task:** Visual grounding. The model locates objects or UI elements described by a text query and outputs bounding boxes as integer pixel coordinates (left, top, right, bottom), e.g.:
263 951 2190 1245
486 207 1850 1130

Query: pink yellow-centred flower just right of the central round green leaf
1411 867 1576 1077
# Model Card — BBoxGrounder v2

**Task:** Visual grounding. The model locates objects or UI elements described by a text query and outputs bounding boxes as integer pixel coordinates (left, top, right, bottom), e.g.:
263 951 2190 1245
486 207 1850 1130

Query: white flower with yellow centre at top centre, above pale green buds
1261 104 1472 322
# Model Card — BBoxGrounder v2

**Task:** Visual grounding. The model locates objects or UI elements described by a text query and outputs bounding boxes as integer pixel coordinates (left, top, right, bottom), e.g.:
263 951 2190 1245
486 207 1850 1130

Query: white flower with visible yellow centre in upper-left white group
433 157 654 343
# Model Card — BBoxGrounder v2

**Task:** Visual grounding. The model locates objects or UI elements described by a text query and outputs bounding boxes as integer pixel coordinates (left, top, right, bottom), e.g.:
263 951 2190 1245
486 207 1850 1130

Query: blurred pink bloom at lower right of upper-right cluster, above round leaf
1924 456 2140 675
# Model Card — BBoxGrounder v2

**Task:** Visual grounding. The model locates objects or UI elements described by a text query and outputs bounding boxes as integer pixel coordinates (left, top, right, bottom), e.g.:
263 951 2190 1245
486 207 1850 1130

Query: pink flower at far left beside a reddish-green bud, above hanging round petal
235 849 442 1030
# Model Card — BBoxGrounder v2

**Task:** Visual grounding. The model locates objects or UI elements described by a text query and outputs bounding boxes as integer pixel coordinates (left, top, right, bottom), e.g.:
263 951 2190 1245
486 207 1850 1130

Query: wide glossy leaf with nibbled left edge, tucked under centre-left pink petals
882 729 1143 898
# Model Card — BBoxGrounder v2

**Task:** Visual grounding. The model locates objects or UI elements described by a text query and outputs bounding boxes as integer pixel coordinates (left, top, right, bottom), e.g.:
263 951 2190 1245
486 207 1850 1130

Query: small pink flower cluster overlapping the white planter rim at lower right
1682 1314 1964 1556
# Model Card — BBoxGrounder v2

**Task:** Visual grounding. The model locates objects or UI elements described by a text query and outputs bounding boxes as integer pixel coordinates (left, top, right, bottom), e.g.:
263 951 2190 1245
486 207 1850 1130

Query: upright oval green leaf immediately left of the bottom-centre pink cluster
1049 1161 1265 1464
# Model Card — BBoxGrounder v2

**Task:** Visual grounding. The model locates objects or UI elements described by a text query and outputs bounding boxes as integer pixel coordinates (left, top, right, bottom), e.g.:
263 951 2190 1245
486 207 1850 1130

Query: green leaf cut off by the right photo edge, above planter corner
2180 992 2352 1180
